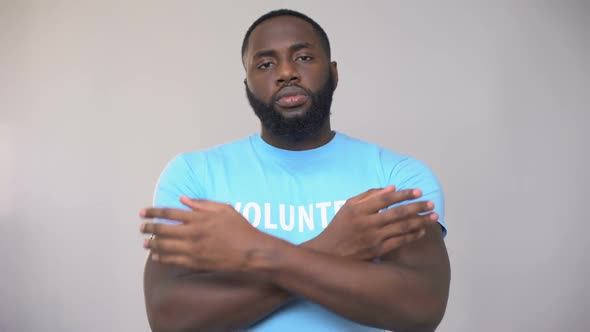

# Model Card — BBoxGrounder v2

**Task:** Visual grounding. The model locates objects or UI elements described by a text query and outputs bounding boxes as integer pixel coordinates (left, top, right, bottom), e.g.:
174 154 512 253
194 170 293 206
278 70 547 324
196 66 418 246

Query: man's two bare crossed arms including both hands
143 189 450 332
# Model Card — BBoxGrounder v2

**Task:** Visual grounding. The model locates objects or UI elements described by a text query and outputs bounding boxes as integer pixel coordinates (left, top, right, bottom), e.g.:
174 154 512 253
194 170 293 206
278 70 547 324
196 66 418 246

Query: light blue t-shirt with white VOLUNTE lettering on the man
154 132 446 332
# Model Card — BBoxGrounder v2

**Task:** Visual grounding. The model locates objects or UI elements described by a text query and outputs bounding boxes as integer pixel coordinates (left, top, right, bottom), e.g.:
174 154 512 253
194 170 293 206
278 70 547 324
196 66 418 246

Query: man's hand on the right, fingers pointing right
304 186 438 260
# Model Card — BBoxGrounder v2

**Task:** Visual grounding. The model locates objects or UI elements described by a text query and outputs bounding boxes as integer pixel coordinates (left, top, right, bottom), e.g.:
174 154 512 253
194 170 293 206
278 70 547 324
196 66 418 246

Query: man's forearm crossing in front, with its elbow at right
253 236 448 331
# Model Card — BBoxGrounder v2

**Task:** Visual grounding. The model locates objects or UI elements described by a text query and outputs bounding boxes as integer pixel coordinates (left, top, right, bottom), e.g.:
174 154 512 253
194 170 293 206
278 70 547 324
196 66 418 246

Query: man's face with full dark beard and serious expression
243 16 337 138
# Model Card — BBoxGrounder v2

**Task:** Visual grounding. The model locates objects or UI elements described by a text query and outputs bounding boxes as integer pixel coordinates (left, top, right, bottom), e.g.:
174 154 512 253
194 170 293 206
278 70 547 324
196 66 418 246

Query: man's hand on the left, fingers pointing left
140 197 271 271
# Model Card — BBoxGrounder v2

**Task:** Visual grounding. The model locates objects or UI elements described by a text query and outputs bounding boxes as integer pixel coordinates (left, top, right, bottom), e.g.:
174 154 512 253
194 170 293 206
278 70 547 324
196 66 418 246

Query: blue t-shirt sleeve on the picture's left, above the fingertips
153 154 204 224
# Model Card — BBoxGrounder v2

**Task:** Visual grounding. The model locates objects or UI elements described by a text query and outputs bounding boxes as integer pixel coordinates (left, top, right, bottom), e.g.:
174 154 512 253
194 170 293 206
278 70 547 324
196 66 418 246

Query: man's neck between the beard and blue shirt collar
260 120 335 151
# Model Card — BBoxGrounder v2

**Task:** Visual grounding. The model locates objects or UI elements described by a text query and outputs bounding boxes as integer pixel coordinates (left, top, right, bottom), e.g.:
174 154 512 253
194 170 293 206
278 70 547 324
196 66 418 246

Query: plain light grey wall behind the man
0 0 590 332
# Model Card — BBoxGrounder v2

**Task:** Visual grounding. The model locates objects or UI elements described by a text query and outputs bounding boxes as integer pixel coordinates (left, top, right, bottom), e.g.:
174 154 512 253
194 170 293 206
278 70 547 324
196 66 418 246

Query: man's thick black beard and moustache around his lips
246 70 336 141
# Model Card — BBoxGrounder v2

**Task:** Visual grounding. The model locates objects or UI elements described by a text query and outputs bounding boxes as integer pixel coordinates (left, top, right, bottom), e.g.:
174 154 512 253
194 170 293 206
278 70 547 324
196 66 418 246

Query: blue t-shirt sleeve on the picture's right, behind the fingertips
389 157 447 236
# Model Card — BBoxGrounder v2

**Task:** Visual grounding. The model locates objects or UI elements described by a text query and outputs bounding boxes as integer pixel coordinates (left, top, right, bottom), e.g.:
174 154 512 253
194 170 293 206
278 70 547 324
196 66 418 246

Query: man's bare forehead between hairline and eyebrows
245 16 320 57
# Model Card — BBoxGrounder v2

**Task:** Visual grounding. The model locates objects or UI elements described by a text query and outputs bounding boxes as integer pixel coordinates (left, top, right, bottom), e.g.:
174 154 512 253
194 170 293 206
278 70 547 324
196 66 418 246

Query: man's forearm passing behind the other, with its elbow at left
145 240 328 332
